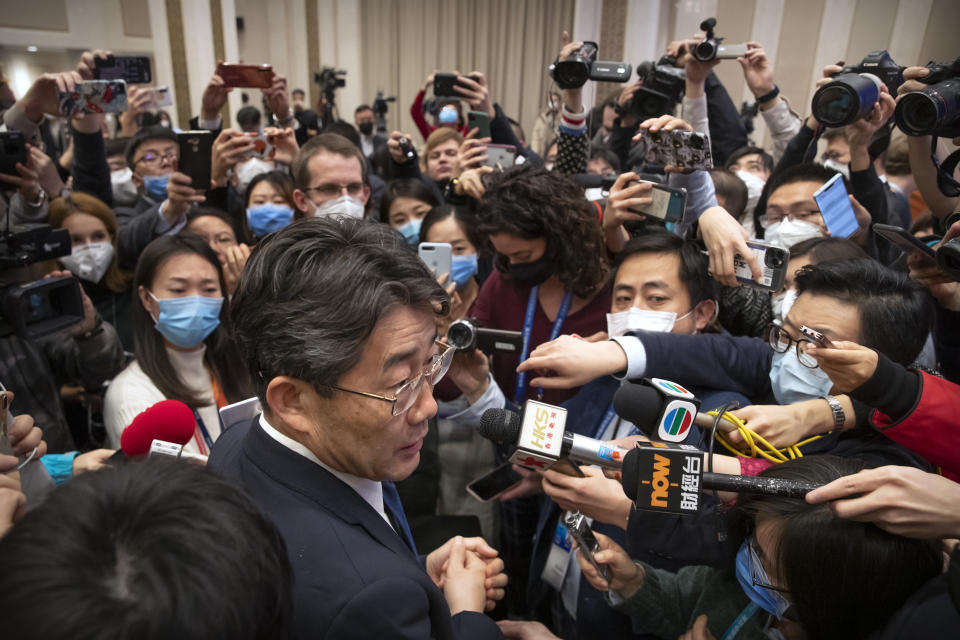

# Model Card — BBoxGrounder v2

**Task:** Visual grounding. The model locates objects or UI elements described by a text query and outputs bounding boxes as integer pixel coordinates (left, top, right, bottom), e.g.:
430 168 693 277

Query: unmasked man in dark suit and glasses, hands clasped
210 217 506 639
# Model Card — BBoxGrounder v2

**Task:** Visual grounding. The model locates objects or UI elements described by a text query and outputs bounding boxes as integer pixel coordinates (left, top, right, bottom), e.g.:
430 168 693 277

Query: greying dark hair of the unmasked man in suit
231 218 449 406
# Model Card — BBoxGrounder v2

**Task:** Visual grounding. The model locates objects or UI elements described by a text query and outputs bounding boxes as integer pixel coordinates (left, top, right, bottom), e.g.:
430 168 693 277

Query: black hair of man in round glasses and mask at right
797 258 933 367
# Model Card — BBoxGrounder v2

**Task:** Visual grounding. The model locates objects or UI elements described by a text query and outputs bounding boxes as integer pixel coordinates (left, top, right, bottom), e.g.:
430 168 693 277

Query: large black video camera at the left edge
0 224 83 339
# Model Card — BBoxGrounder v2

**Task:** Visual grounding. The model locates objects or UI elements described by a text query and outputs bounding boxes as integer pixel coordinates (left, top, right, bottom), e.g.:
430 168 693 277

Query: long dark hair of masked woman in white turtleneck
132 234 251 409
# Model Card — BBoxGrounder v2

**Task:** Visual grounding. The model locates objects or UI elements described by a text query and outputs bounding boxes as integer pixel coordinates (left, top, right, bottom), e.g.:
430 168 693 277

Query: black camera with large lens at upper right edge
893 58 960 138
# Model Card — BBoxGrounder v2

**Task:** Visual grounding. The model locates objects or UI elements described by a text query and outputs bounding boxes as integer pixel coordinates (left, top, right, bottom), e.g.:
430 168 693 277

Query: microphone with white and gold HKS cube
478 400 627 475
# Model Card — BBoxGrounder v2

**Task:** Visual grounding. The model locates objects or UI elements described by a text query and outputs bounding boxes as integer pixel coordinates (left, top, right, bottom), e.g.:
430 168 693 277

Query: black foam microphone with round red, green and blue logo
613 378 737 442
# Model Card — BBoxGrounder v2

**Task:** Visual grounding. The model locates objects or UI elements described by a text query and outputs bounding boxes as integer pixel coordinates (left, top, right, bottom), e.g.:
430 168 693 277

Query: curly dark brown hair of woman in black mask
477 163 610 298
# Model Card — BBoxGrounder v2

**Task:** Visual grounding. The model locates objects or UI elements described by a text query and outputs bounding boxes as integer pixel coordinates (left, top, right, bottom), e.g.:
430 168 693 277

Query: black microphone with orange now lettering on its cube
620 442 822 514
